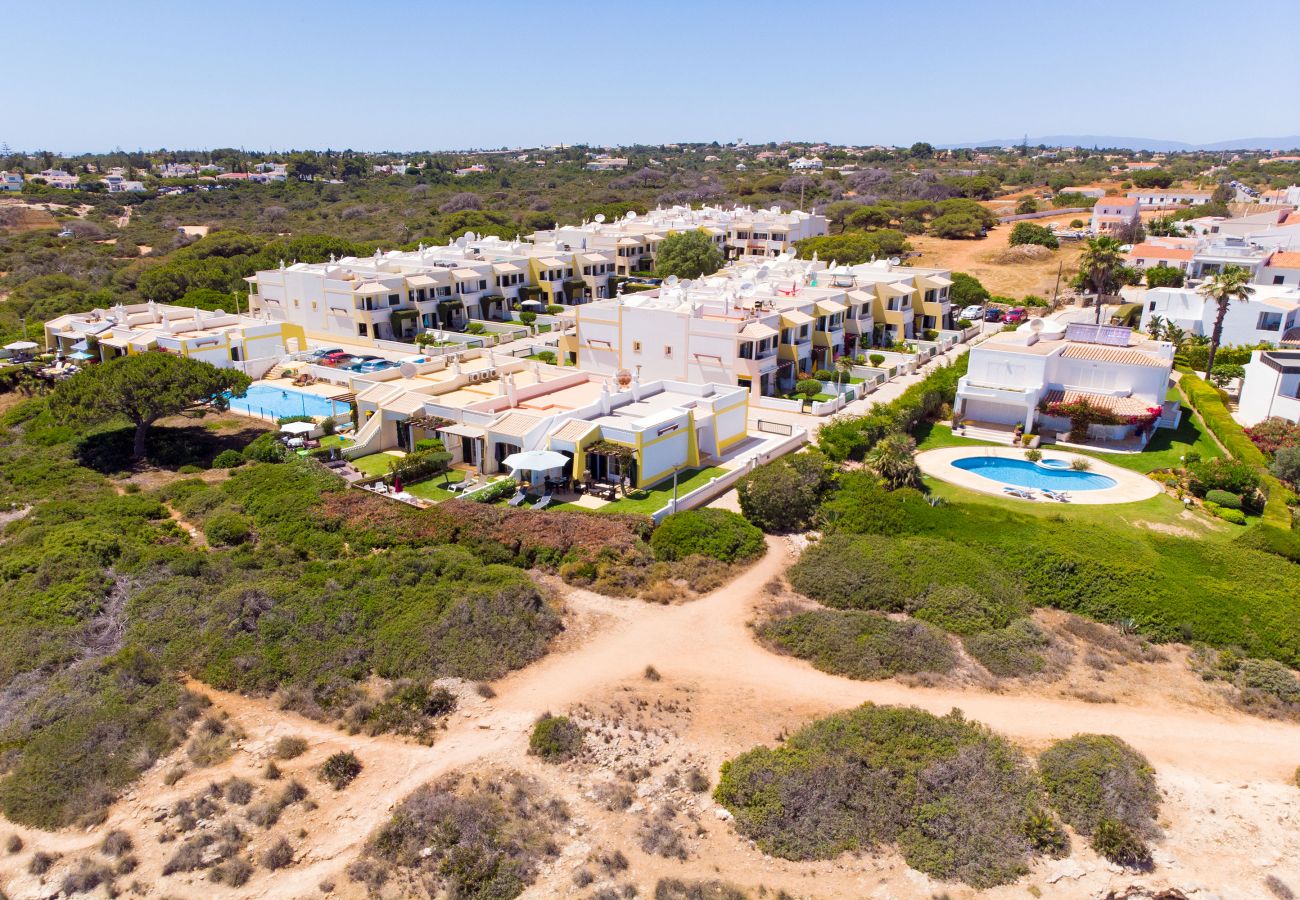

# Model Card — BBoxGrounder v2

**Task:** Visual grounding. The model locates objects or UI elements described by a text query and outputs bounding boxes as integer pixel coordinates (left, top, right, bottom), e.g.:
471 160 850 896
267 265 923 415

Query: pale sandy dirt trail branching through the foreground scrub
0 538 1300 899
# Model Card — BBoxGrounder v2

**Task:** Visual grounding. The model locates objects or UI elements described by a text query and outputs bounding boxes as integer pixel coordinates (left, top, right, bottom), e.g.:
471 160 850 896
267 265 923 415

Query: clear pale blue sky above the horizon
0 0 1300 152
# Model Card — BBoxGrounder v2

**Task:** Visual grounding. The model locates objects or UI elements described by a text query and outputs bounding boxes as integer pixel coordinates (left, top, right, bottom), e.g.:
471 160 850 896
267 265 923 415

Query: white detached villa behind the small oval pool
954 319 1174 440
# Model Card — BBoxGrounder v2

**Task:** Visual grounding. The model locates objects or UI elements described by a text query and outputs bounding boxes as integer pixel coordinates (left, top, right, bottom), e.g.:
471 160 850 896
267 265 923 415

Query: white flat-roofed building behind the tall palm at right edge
1140 285 1300 346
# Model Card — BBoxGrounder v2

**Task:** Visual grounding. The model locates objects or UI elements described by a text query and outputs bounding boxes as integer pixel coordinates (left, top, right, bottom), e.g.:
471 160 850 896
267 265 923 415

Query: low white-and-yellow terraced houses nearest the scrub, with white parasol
348 351 749 488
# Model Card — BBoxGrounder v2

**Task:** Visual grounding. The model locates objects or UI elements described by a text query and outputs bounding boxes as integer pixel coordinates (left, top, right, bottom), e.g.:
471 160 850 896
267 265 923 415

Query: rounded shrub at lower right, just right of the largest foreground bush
1039 735 1160 858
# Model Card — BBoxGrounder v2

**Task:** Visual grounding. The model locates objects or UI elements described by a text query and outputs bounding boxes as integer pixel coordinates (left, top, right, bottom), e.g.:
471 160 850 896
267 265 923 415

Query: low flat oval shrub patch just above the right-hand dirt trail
758 610 957 680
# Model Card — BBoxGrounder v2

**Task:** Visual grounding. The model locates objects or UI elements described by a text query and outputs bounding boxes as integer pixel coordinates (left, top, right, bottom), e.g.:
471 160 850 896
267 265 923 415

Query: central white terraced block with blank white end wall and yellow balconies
560 255 952 395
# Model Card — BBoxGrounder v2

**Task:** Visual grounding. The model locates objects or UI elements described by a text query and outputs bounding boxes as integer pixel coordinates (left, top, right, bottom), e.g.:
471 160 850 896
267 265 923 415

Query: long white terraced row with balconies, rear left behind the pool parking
246 234 614 342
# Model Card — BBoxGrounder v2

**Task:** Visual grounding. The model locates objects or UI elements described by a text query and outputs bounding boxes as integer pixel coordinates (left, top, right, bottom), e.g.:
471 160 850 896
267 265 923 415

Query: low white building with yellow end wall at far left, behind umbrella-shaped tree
46 302 307 378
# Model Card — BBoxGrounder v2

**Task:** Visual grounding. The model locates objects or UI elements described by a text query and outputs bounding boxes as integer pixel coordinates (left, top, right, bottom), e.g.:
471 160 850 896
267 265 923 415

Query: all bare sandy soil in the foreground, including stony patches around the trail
0 538 1300 899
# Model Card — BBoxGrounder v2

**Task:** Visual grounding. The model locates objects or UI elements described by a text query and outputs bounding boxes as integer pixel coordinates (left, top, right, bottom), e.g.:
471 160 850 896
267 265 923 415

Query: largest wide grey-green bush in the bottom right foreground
714 704 1060 888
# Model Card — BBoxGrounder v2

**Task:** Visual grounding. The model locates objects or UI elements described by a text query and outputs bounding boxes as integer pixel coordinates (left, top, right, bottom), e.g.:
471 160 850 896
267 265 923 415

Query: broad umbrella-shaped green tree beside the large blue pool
49 352 251 459
